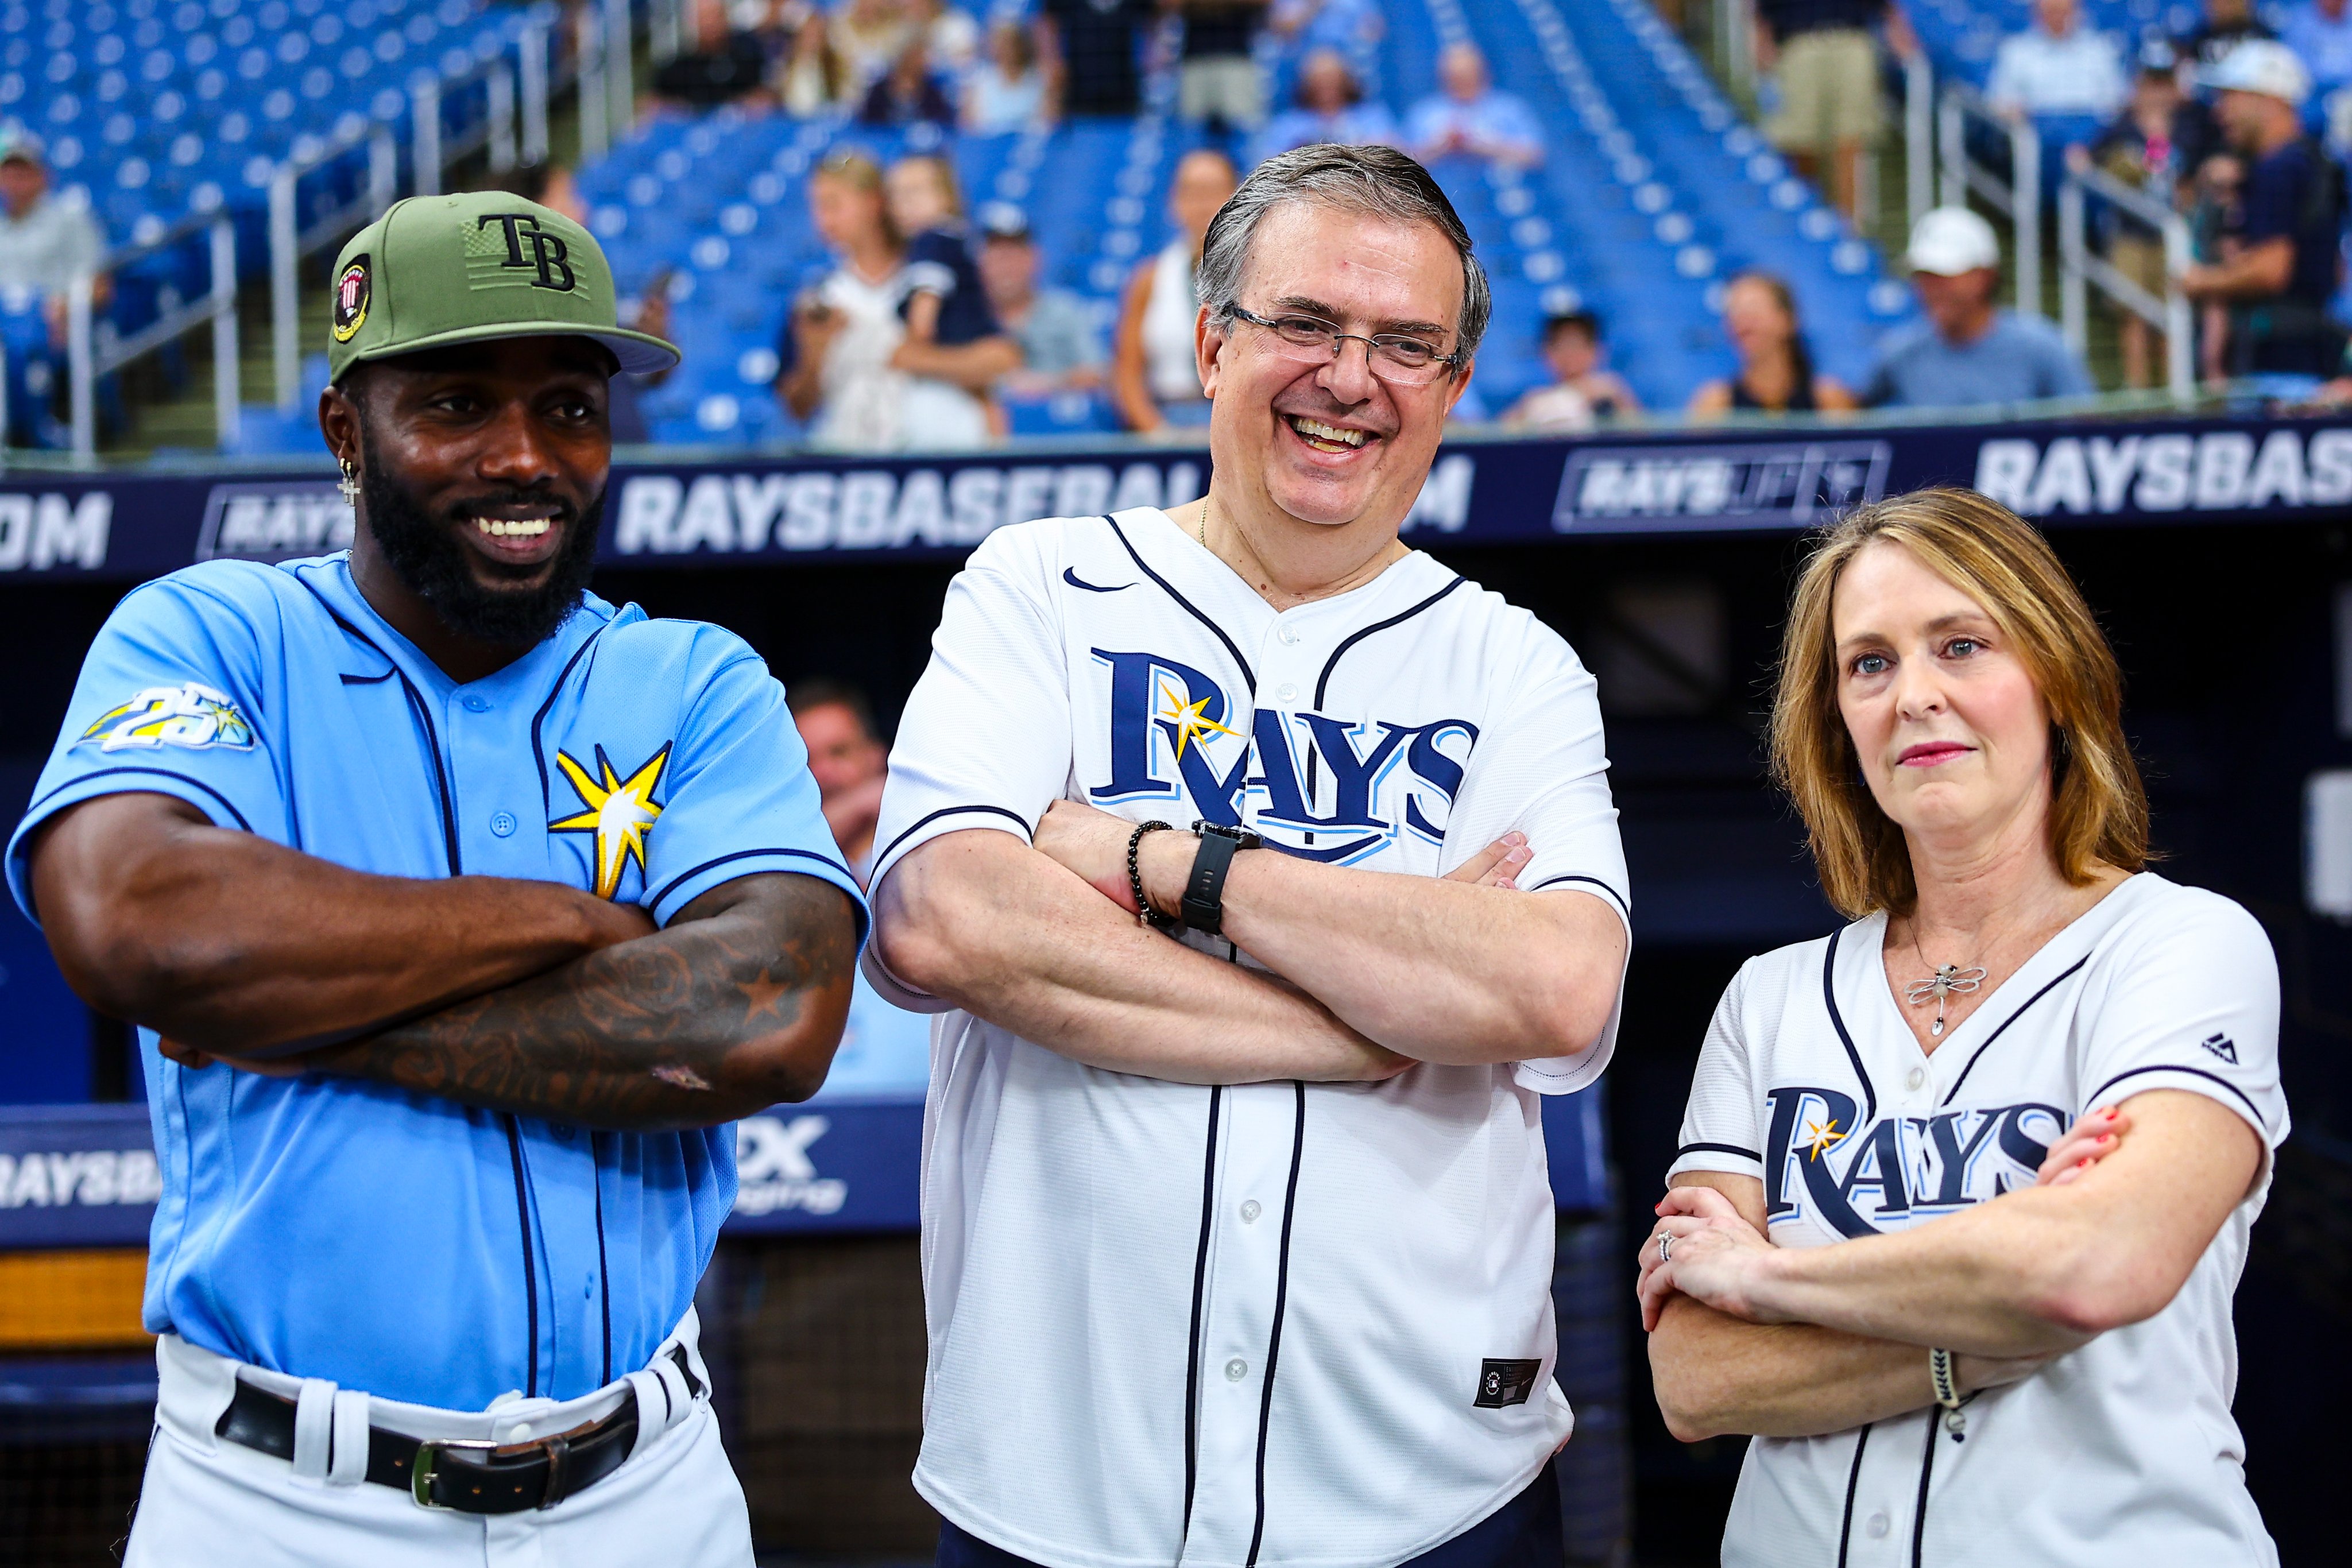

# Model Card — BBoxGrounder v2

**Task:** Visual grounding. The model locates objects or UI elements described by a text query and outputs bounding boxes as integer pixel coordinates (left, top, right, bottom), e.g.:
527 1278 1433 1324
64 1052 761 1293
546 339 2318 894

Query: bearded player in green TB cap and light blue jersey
7 195 863 1568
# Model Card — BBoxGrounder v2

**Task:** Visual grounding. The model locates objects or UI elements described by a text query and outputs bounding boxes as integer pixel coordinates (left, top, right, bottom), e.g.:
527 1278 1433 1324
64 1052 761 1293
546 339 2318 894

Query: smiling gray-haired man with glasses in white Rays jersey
868 146 1627 1568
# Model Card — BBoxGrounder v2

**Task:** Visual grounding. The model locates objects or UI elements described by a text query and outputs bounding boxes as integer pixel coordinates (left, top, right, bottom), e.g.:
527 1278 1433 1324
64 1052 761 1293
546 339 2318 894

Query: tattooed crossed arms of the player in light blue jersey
33 795 856 1130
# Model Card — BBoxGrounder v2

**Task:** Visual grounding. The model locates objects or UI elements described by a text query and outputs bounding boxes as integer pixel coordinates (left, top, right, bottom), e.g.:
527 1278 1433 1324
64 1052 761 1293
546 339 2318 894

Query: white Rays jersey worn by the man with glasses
868 508 1625 1568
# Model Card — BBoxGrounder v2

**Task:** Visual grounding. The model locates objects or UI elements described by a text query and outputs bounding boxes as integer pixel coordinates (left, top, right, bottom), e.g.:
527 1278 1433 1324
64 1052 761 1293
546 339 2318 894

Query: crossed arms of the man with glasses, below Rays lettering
875 802 1625 1084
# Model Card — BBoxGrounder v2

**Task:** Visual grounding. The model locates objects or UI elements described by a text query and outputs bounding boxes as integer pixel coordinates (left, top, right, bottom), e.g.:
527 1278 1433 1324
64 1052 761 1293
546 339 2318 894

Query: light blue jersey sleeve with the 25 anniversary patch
7 567 289 922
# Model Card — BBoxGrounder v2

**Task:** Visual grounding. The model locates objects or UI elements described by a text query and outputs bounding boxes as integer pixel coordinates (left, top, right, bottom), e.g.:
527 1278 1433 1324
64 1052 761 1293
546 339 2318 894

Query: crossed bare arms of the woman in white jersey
1639 1089 2262 1441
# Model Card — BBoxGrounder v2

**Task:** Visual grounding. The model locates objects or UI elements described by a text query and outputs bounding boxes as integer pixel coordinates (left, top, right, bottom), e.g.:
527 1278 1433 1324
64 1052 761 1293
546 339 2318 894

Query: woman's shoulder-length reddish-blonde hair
1771 489 2148 919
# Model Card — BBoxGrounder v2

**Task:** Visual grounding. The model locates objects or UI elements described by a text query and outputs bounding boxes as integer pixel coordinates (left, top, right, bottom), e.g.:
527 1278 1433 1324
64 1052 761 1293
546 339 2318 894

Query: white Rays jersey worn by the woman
1674 872 2286 1568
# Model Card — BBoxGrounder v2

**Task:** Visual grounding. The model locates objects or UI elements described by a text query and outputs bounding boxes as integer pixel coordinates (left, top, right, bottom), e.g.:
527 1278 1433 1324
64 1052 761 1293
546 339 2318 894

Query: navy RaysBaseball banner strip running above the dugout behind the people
0 419 2352 583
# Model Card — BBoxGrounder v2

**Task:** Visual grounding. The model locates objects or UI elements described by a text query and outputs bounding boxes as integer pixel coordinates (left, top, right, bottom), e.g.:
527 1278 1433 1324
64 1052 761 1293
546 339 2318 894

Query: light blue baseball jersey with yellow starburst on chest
7 555 865 1411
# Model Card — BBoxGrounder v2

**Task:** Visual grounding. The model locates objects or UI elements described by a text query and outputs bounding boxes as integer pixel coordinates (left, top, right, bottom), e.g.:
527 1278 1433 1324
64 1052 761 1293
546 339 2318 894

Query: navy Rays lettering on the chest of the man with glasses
1086 649 1477 863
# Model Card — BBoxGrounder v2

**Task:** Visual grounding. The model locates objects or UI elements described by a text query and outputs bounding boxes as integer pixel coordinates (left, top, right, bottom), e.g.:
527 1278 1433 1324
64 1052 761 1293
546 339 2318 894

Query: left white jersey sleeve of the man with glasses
865 529 1073 1011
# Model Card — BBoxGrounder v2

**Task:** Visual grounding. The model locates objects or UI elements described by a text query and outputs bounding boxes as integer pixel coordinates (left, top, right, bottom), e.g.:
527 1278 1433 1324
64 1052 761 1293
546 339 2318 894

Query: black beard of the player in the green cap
360 454 605 649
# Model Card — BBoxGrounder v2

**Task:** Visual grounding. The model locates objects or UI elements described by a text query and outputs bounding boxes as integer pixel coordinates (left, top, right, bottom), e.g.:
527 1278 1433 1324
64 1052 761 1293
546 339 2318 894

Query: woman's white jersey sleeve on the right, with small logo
2069 889 2286 1149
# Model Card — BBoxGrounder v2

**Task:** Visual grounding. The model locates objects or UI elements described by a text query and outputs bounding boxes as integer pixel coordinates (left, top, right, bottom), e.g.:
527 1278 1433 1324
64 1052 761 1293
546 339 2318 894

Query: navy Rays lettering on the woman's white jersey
1764 1084 2067 1237
